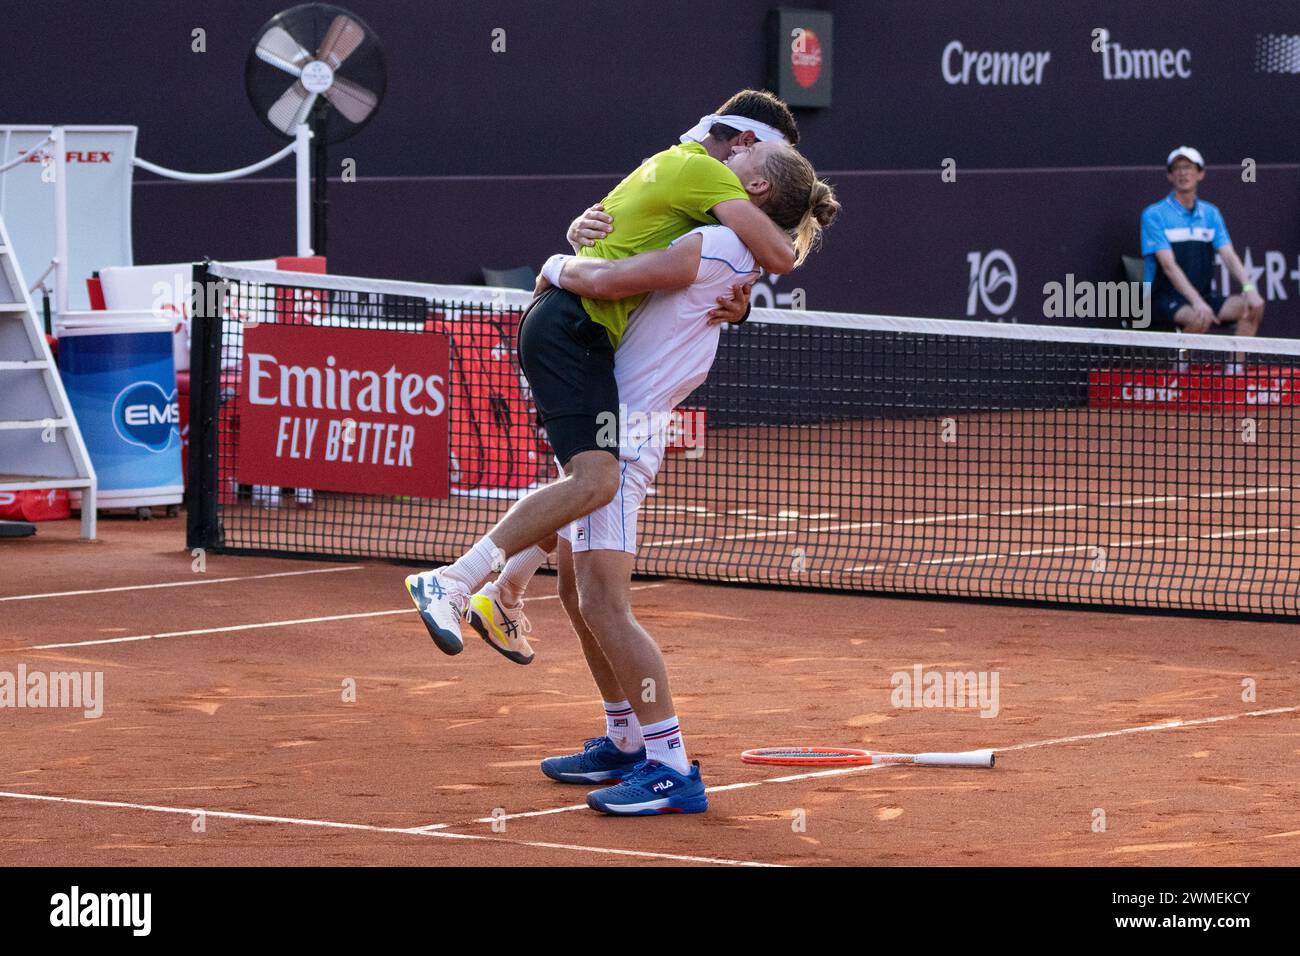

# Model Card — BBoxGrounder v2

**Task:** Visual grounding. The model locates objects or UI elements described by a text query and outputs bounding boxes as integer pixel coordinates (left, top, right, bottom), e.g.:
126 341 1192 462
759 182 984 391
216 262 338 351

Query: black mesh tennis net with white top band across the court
189 263 1300 617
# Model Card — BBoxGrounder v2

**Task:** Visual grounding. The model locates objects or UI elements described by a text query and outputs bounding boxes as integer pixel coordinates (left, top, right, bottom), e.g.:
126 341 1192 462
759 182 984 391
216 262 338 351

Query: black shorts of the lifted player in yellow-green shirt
519 287 619 466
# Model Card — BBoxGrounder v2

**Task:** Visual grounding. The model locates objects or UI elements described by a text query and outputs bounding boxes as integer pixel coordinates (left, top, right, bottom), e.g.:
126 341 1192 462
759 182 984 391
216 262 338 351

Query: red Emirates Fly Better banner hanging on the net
237 323 450 498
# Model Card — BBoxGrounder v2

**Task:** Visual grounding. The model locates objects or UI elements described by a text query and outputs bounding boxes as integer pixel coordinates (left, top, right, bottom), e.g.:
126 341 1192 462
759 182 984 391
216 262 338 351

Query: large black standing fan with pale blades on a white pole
244 4 387 255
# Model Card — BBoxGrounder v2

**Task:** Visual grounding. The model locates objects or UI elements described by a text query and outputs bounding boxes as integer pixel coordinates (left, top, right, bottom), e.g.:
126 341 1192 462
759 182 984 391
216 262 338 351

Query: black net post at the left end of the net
185 261 225 548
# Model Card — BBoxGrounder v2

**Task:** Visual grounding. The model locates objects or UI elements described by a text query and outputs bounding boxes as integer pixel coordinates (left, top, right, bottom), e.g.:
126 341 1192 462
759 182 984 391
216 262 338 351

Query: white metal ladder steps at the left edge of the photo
0 210 99 540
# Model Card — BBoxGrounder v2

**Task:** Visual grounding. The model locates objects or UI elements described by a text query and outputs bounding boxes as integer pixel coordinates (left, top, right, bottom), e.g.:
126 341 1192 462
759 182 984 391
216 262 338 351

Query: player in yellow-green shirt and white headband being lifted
406 90 798 654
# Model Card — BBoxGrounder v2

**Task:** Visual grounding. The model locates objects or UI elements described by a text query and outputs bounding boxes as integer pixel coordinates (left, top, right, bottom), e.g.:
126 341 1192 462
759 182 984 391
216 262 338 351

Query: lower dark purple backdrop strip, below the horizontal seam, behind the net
137 165 1300 337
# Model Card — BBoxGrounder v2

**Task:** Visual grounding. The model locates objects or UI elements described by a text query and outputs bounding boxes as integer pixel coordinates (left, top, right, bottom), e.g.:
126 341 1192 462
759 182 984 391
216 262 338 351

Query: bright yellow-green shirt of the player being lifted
579 143 749 349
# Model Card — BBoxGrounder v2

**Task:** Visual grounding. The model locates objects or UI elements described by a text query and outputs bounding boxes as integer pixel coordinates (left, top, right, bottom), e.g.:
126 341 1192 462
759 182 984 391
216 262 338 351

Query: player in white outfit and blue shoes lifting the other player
468 142 839 816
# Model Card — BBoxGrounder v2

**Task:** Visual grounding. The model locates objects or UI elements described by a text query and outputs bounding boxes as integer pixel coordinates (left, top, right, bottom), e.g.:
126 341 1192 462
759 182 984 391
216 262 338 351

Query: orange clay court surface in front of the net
0 518 1300 866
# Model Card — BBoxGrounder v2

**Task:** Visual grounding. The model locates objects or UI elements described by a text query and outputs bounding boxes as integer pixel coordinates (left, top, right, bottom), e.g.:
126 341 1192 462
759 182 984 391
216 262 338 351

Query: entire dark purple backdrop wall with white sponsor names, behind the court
0 0 1300 336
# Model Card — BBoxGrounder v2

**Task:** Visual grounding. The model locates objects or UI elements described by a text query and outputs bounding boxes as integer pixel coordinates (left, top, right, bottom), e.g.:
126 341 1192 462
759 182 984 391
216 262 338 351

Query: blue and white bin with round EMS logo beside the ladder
59 311 185 509
